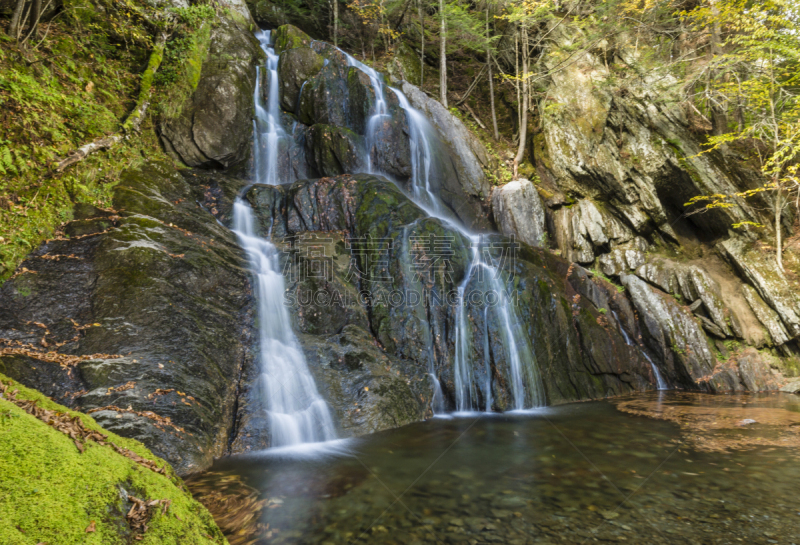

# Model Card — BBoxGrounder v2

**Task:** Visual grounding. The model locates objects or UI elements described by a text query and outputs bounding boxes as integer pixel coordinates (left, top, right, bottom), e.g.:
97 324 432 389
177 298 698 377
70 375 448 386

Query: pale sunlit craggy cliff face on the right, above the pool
493 25 800 390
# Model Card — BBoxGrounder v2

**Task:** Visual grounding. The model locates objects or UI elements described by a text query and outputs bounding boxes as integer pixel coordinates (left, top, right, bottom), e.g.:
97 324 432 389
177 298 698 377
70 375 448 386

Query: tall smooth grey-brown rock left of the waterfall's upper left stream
159 15 264 168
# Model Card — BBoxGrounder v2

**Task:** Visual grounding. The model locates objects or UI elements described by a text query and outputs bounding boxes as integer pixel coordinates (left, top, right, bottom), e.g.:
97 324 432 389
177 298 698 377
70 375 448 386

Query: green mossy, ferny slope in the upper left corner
0 0 170 282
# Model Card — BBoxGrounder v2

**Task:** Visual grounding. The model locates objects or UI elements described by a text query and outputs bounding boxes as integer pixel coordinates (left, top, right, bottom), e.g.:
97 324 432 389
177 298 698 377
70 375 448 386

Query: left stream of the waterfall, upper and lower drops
233 31 336 447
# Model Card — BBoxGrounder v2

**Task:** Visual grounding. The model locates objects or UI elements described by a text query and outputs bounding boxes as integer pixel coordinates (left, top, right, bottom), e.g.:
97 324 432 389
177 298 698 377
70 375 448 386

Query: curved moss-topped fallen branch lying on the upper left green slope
51 32 167 175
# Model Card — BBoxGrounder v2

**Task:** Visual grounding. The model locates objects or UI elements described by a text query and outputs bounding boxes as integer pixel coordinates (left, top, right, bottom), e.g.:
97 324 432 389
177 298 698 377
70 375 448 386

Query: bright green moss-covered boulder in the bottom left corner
0 375 227 545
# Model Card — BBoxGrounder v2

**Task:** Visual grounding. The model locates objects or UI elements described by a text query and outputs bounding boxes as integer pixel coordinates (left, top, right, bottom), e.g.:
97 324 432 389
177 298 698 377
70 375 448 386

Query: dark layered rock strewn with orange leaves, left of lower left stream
0 160 253 474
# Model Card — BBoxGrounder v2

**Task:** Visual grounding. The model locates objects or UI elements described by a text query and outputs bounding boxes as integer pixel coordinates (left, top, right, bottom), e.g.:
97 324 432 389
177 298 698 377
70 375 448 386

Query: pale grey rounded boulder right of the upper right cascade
492 179 547 248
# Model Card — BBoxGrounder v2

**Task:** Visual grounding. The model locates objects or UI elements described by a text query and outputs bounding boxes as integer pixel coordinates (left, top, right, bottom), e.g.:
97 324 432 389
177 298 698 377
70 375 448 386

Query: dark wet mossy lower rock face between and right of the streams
239 175 668 408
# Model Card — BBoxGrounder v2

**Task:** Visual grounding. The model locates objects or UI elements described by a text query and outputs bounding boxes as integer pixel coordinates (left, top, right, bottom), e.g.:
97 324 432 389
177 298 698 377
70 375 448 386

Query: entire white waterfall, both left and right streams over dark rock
247 31 545 420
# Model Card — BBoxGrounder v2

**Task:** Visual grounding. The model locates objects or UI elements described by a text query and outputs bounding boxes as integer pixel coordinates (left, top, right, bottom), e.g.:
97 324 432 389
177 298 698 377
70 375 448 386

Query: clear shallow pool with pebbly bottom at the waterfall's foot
188 392 800 545
